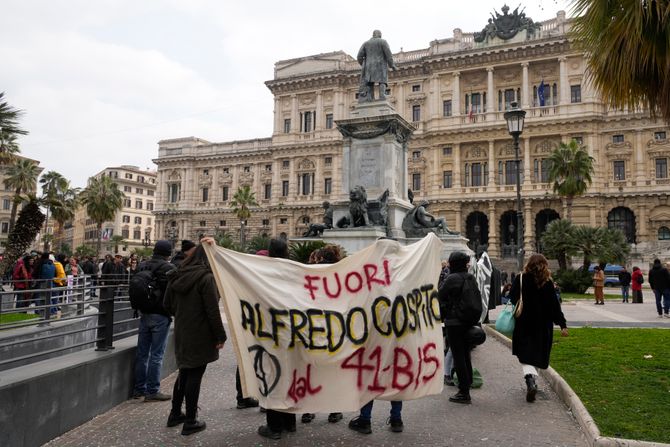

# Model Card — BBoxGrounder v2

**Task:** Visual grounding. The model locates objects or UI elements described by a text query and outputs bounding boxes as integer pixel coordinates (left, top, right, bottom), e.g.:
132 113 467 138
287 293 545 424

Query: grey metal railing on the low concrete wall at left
0 275 139 371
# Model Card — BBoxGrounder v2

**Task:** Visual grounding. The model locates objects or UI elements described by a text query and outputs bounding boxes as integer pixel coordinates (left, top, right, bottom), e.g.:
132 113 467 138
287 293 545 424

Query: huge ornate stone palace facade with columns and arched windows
154 11 670 264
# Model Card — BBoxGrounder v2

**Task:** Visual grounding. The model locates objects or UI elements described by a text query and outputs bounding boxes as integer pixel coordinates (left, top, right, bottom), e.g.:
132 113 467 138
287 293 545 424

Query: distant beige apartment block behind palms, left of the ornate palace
72 165 157 256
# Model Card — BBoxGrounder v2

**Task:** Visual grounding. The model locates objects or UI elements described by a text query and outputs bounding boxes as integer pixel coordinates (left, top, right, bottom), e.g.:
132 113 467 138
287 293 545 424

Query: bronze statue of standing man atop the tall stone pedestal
356 30 398 102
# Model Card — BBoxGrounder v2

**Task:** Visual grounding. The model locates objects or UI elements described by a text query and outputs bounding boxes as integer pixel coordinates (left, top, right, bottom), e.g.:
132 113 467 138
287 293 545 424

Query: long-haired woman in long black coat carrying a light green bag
510 254 568 402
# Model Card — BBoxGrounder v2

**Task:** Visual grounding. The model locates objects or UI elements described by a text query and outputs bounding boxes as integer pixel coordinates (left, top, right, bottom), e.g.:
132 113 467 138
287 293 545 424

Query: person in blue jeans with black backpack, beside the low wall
131 240 175 402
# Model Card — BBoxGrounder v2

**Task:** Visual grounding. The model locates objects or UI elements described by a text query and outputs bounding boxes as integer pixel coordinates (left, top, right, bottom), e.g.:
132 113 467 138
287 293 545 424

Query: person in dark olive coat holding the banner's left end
164 246 226 435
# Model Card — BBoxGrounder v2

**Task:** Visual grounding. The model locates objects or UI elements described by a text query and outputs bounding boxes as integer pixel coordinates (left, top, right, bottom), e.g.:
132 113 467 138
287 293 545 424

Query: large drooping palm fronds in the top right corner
571 0 670 122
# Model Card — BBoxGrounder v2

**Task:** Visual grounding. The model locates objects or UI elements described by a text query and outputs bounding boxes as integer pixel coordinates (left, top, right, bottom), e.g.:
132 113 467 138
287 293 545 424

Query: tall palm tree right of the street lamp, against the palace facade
549 140 594 220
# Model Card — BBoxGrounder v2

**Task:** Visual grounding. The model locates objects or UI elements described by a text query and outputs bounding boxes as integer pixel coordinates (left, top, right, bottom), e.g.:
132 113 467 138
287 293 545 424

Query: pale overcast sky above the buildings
0 0 570 186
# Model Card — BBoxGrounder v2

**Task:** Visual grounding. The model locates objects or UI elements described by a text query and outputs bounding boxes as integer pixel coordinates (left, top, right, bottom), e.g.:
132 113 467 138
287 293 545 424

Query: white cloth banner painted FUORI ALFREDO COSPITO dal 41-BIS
206 234 444 413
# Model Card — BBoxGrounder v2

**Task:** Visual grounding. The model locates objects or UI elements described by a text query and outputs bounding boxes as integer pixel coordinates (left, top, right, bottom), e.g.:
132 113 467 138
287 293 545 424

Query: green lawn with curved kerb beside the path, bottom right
551 327 670 443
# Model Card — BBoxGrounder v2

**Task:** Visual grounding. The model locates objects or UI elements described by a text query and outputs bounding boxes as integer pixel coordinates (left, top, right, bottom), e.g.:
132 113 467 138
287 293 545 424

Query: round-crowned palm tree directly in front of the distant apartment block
81 175 125 257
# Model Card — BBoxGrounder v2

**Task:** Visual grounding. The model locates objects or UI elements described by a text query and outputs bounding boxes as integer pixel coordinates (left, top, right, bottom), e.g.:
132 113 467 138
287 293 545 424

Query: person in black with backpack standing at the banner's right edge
438 251 483 404
